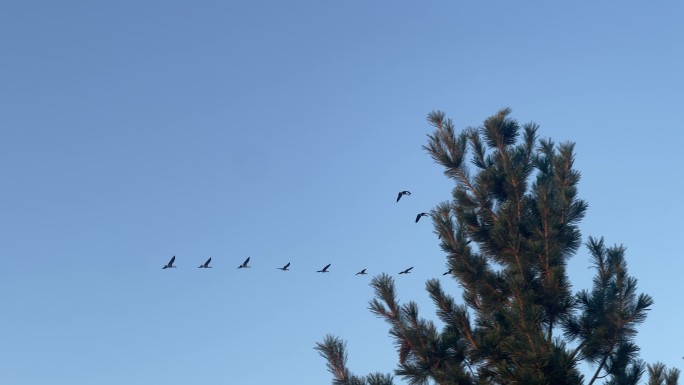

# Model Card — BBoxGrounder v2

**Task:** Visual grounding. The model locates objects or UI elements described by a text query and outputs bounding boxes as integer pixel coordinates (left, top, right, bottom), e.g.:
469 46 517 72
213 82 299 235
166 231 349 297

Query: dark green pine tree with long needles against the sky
316 109 678 385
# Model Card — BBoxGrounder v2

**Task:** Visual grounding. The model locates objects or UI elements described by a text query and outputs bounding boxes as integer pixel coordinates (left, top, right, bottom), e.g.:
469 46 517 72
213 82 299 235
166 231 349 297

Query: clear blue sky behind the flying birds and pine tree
0 0 684 385
